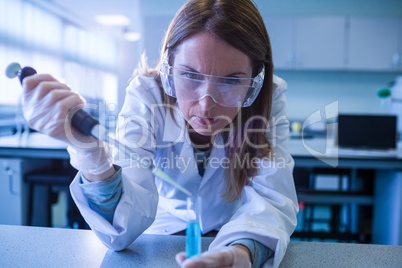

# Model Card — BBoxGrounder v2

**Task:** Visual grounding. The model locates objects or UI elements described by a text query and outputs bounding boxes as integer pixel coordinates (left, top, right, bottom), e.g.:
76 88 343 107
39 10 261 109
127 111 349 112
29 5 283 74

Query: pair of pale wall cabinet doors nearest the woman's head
265 16 345 70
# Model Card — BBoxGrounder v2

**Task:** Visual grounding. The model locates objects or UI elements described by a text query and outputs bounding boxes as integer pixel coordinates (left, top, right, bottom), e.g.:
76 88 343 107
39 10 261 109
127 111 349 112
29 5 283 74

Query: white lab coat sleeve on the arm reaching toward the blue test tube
210 77 298 267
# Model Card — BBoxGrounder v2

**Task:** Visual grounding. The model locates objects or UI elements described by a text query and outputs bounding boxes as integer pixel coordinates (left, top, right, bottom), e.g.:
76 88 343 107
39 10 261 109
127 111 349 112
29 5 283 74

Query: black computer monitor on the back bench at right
338 114 397 150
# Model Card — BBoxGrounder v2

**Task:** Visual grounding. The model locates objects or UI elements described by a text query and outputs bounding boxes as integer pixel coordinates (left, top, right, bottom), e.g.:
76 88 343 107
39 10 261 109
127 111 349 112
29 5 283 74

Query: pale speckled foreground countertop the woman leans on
0 225 402 268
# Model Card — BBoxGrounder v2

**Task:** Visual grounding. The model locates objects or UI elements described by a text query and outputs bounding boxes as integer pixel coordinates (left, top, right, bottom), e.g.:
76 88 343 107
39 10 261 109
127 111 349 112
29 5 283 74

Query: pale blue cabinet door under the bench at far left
0 159 23 225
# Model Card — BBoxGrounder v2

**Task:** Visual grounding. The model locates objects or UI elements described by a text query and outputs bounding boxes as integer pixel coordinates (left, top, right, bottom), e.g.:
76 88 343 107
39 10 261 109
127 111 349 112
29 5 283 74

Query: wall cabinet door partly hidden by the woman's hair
264 17 295 69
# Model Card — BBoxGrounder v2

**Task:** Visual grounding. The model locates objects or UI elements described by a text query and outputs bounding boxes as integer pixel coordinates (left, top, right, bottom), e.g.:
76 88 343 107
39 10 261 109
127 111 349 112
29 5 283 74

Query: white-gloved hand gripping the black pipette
23 74 114 181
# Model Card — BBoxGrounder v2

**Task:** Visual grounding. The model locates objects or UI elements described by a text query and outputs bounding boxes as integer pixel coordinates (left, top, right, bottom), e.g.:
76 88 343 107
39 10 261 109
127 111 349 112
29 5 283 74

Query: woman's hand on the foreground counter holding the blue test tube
176 245 251 268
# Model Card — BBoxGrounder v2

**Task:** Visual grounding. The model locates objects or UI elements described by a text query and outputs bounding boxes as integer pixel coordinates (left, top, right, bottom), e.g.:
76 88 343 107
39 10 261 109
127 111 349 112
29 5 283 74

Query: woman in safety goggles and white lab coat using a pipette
24 0 298 267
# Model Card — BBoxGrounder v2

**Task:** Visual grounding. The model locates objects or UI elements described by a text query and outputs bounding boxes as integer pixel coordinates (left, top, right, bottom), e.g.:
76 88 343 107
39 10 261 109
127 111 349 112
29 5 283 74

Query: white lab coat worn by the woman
70 76 298 267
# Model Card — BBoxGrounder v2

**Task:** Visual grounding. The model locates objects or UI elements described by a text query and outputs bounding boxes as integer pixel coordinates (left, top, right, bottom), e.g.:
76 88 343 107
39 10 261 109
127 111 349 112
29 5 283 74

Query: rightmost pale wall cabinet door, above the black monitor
348 18 399 71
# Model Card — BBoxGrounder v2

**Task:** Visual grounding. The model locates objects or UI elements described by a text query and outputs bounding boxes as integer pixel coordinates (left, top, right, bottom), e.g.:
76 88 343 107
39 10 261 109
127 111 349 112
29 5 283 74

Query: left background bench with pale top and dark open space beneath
0 132 75 226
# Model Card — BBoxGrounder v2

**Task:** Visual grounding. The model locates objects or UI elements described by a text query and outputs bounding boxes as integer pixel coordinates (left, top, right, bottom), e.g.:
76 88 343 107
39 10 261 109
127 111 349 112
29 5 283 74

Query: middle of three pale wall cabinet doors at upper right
295 17 345 70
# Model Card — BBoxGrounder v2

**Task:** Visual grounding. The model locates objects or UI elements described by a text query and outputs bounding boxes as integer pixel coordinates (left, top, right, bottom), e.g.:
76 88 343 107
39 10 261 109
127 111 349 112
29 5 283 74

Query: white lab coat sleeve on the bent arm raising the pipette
70 78 164 250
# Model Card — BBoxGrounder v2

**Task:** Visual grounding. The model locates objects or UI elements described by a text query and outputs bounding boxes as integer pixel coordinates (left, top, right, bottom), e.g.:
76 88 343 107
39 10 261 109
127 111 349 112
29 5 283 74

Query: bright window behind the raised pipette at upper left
0 0 118 112
